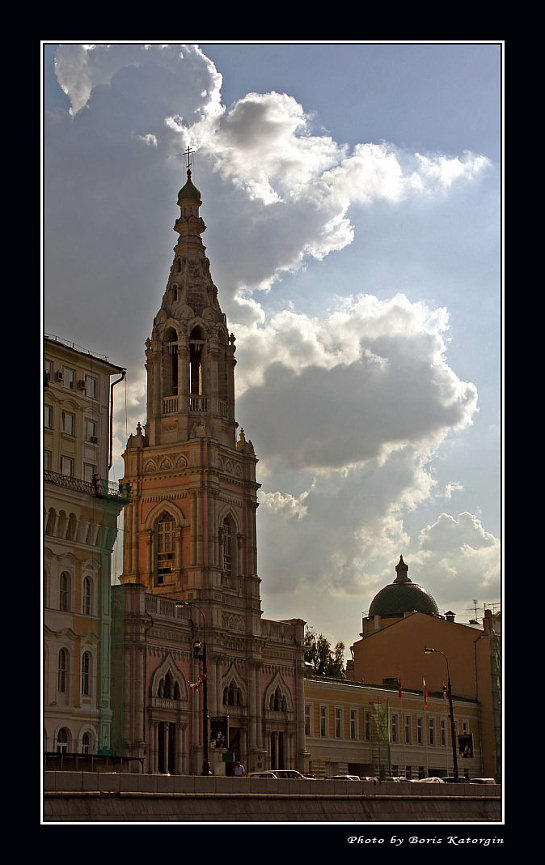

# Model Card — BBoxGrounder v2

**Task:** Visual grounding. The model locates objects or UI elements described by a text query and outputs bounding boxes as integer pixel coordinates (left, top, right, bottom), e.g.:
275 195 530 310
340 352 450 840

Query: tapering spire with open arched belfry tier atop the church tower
142 148 236 445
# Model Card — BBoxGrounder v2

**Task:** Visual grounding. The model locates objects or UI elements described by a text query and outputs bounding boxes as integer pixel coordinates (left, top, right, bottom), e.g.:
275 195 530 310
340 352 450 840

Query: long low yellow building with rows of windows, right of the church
305 676 482 779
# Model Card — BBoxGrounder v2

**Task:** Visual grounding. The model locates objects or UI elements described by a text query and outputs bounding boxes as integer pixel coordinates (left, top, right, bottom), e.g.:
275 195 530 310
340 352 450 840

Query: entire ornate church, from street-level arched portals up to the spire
112 169 305 774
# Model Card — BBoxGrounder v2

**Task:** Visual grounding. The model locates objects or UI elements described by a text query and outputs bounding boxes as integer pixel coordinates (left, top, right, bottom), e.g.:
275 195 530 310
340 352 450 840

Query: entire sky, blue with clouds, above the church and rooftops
43 42 502 645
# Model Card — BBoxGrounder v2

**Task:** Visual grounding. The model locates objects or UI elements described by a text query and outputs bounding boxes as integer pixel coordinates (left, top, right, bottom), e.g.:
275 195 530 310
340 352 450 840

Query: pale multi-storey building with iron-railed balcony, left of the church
43 336 128 753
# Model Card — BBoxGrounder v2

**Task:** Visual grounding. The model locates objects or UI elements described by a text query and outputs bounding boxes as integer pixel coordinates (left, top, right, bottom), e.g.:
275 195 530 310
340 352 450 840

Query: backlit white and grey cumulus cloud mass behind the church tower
45 44 498 627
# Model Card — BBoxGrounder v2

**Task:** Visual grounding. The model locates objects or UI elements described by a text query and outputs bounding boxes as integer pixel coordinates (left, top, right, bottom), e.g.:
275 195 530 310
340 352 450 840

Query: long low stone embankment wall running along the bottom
43 772 501 823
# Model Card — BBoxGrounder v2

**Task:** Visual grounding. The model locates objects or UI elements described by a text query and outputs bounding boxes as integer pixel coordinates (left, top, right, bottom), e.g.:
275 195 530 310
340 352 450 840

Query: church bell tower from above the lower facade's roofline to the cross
121 155 260 626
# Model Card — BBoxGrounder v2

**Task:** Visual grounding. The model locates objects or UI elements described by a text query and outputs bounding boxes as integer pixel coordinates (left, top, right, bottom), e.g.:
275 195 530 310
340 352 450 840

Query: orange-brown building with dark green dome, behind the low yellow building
350 557 502 781
